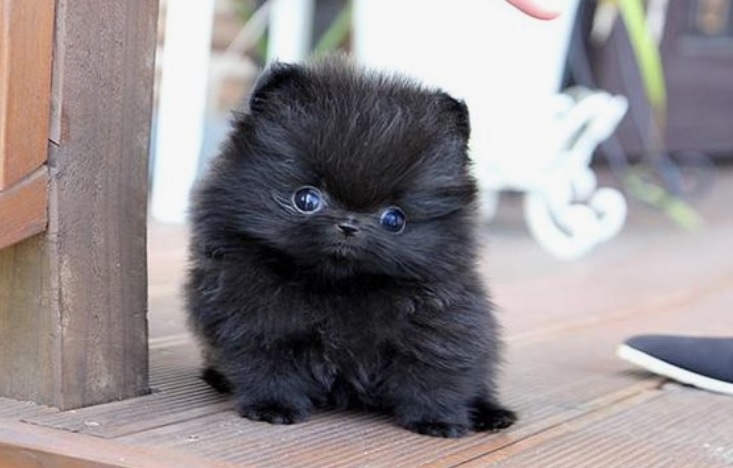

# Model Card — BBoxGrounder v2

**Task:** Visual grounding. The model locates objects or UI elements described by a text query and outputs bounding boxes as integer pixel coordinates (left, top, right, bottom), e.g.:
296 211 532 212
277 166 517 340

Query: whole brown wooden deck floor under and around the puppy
0 169 733 468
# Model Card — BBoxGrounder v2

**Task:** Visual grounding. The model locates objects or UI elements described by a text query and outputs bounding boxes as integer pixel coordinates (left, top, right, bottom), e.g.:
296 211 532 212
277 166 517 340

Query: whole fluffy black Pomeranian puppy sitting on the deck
186 58 515 437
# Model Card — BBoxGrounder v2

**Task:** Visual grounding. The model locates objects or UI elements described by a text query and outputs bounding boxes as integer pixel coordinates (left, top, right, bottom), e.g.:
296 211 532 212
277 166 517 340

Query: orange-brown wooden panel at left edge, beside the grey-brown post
0 0 55 248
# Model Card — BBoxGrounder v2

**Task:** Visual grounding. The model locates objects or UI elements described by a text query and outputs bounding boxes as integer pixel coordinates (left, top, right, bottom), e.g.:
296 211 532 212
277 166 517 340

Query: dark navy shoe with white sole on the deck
616 335 733 395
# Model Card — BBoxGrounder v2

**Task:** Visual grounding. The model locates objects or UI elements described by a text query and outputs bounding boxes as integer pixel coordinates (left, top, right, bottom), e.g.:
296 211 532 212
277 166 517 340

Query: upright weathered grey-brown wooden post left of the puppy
49 0 158 408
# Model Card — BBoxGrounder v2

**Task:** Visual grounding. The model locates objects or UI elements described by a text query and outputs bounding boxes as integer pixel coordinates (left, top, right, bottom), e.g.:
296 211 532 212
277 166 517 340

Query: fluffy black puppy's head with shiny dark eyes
217 58 476 277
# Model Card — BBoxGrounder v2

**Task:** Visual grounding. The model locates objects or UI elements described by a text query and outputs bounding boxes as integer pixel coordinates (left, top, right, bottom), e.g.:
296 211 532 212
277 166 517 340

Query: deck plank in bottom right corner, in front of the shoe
460 384 733 468
